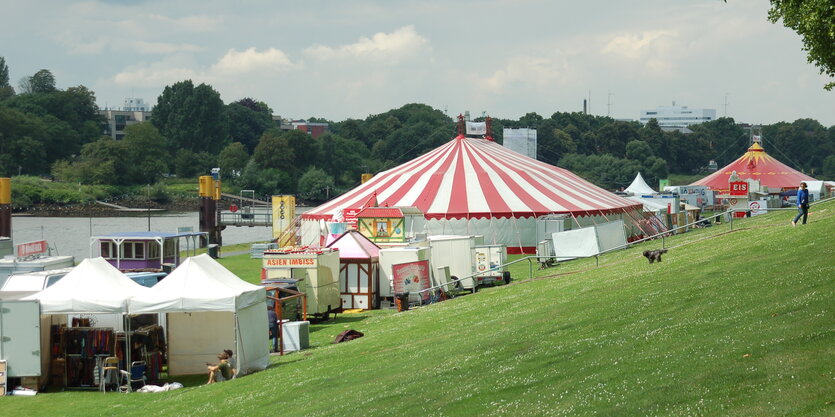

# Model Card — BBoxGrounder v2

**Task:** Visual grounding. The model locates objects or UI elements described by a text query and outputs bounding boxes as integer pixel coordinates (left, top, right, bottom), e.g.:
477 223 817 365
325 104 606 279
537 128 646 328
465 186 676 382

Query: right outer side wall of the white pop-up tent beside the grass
235 301 270 375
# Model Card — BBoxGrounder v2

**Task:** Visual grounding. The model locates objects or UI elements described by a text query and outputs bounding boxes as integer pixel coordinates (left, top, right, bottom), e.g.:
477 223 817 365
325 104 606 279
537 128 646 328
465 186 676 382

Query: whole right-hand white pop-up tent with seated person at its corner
129 254 269 375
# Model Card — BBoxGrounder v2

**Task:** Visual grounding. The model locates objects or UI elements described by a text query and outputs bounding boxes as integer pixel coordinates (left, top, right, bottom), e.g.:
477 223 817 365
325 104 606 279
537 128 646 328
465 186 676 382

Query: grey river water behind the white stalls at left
12 212 272 262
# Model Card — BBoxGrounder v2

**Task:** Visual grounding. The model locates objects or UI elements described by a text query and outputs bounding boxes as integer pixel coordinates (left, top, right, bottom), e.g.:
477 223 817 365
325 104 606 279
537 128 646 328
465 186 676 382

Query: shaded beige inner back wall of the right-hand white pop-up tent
166 307 235 377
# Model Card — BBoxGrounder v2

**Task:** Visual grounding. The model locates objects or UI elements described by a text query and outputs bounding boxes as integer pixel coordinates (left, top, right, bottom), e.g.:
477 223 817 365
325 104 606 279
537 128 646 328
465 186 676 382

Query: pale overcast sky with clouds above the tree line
0 0 835 126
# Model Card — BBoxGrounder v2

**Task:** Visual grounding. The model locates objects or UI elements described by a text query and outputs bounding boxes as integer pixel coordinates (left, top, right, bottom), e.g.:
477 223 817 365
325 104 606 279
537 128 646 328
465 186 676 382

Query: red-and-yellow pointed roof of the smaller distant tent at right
690 142 815 191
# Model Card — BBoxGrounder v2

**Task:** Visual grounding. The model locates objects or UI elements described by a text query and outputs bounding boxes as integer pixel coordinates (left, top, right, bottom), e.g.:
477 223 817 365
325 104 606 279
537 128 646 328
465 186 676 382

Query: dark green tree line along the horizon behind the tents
0 57 835 201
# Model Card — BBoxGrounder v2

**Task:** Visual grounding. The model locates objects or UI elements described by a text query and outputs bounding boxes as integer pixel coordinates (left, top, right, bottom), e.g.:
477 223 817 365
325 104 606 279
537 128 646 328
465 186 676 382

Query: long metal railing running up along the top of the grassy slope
406 197 835 304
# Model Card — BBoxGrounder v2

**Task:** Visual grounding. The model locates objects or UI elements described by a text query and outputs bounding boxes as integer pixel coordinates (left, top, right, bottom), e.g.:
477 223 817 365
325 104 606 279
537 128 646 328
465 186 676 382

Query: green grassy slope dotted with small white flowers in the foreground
6 203 835 416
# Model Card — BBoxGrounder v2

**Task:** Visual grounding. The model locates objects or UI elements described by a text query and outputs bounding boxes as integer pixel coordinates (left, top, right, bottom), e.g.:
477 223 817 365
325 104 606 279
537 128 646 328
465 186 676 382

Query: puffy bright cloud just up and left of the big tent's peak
305 25 429 61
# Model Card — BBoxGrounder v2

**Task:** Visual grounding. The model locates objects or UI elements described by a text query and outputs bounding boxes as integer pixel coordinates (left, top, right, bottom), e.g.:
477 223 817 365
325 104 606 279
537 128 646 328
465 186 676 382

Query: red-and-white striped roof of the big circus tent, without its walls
302 136 640 220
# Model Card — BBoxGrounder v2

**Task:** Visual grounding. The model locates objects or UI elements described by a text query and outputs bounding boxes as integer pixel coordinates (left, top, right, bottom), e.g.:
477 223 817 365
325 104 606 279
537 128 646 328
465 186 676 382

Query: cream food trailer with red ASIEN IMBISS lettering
261 249 342 320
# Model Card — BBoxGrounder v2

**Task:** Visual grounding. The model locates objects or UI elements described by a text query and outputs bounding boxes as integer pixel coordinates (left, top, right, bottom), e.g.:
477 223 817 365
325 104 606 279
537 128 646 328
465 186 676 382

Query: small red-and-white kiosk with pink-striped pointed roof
328 230 380 310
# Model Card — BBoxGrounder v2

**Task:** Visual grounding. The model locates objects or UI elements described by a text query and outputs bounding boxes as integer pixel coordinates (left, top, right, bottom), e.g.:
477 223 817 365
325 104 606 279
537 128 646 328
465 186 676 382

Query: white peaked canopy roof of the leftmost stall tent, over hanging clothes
24 258 149 314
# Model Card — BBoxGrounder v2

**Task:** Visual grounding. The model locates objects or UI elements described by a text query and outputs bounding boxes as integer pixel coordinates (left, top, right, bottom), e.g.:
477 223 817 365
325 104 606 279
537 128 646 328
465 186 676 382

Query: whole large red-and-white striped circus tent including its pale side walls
301 135 642 253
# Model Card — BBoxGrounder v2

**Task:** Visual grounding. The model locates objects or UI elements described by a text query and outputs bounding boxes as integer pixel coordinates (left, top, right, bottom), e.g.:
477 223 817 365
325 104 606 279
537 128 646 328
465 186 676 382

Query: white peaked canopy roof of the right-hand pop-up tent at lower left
130 254 266 314
